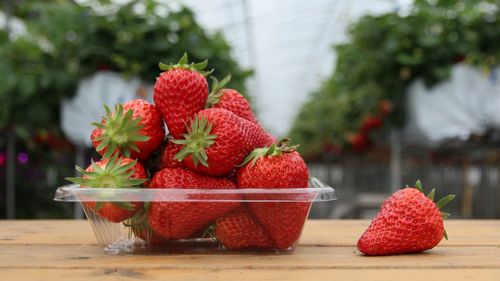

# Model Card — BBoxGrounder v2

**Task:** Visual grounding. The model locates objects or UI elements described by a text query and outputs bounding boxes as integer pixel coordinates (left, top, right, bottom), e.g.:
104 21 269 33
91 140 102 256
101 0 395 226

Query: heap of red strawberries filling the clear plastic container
68 54 310 249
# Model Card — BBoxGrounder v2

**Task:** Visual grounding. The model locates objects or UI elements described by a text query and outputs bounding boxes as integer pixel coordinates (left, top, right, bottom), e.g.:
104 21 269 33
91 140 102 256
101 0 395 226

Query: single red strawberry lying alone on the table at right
358 181 455 255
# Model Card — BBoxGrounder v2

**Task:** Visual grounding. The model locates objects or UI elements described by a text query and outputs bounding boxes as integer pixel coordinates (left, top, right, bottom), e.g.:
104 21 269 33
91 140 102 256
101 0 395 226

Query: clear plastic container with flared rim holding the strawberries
54 178 336 254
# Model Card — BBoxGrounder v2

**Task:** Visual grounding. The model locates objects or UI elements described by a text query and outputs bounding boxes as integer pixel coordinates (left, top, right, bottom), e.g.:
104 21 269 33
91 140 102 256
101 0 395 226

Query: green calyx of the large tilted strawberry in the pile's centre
173 115 217 168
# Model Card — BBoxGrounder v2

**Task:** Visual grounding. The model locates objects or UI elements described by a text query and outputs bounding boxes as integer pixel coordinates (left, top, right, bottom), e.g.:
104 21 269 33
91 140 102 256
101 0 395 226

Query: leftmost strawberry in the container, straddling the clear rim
66 154 147 222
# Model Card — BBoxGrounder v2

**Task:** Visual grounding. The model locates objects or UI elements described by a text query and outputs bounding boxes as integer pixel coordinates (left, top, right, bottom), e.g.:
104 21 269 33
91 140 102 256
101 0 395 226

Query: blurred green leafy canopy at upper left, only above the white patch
0 0 251 137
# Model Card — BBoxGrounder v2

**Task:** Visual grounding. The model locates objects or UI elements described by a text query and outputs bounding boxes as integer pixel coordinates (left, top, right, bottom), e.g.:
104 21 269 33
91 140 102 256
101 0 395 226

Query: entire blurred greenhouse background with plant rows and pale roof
0 0 500 219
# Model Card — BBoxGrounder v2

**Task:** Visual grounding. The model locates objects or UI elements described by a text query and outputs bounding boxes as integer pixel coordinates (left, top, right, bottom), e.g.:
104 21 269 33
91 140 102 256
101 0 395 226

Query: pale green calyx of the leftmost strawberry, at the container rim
66 154 147 211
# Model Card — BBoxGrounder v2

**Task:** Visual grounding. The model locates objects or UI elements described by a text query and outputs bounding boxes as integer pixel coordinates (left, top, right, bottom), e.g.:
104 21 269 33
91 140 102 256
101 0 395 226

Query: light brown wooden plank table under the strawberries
0 220 500 281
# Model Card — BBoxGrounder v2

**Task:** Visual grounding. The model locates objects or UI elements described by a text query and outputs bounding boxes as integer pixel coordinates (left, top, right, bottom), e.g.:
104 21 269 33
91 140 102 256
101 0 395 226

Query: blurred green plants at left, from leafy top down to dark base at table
0 0 252 218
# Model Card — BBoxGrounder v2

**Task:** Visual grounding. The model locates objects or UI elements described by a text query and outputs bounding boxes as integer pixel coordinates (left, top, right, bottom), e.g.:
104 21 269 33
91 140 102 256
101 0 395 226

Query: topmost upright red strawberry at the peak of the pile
153 54 210 138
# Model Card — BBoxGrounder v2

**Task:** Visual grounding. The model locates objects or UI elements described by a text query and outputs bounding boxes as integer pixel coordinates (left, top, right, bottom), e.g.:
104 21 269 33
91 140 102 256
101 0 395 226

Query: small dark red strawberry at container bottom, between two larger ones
214 206 274 250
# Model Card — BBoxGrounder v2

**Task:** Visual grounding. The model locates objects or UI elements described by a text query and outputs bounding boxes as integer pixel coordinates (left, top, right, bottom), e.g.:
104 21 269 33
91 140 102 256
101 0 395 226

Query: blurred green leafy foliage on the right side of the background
291 0 500 156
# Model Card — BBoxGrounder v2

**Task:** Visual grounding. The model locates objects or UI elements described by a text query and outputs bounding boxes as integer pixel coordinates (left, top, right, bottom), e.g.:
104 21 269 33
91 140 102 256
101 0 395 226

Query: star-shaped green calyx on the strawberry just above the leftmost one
92 104 150 158
